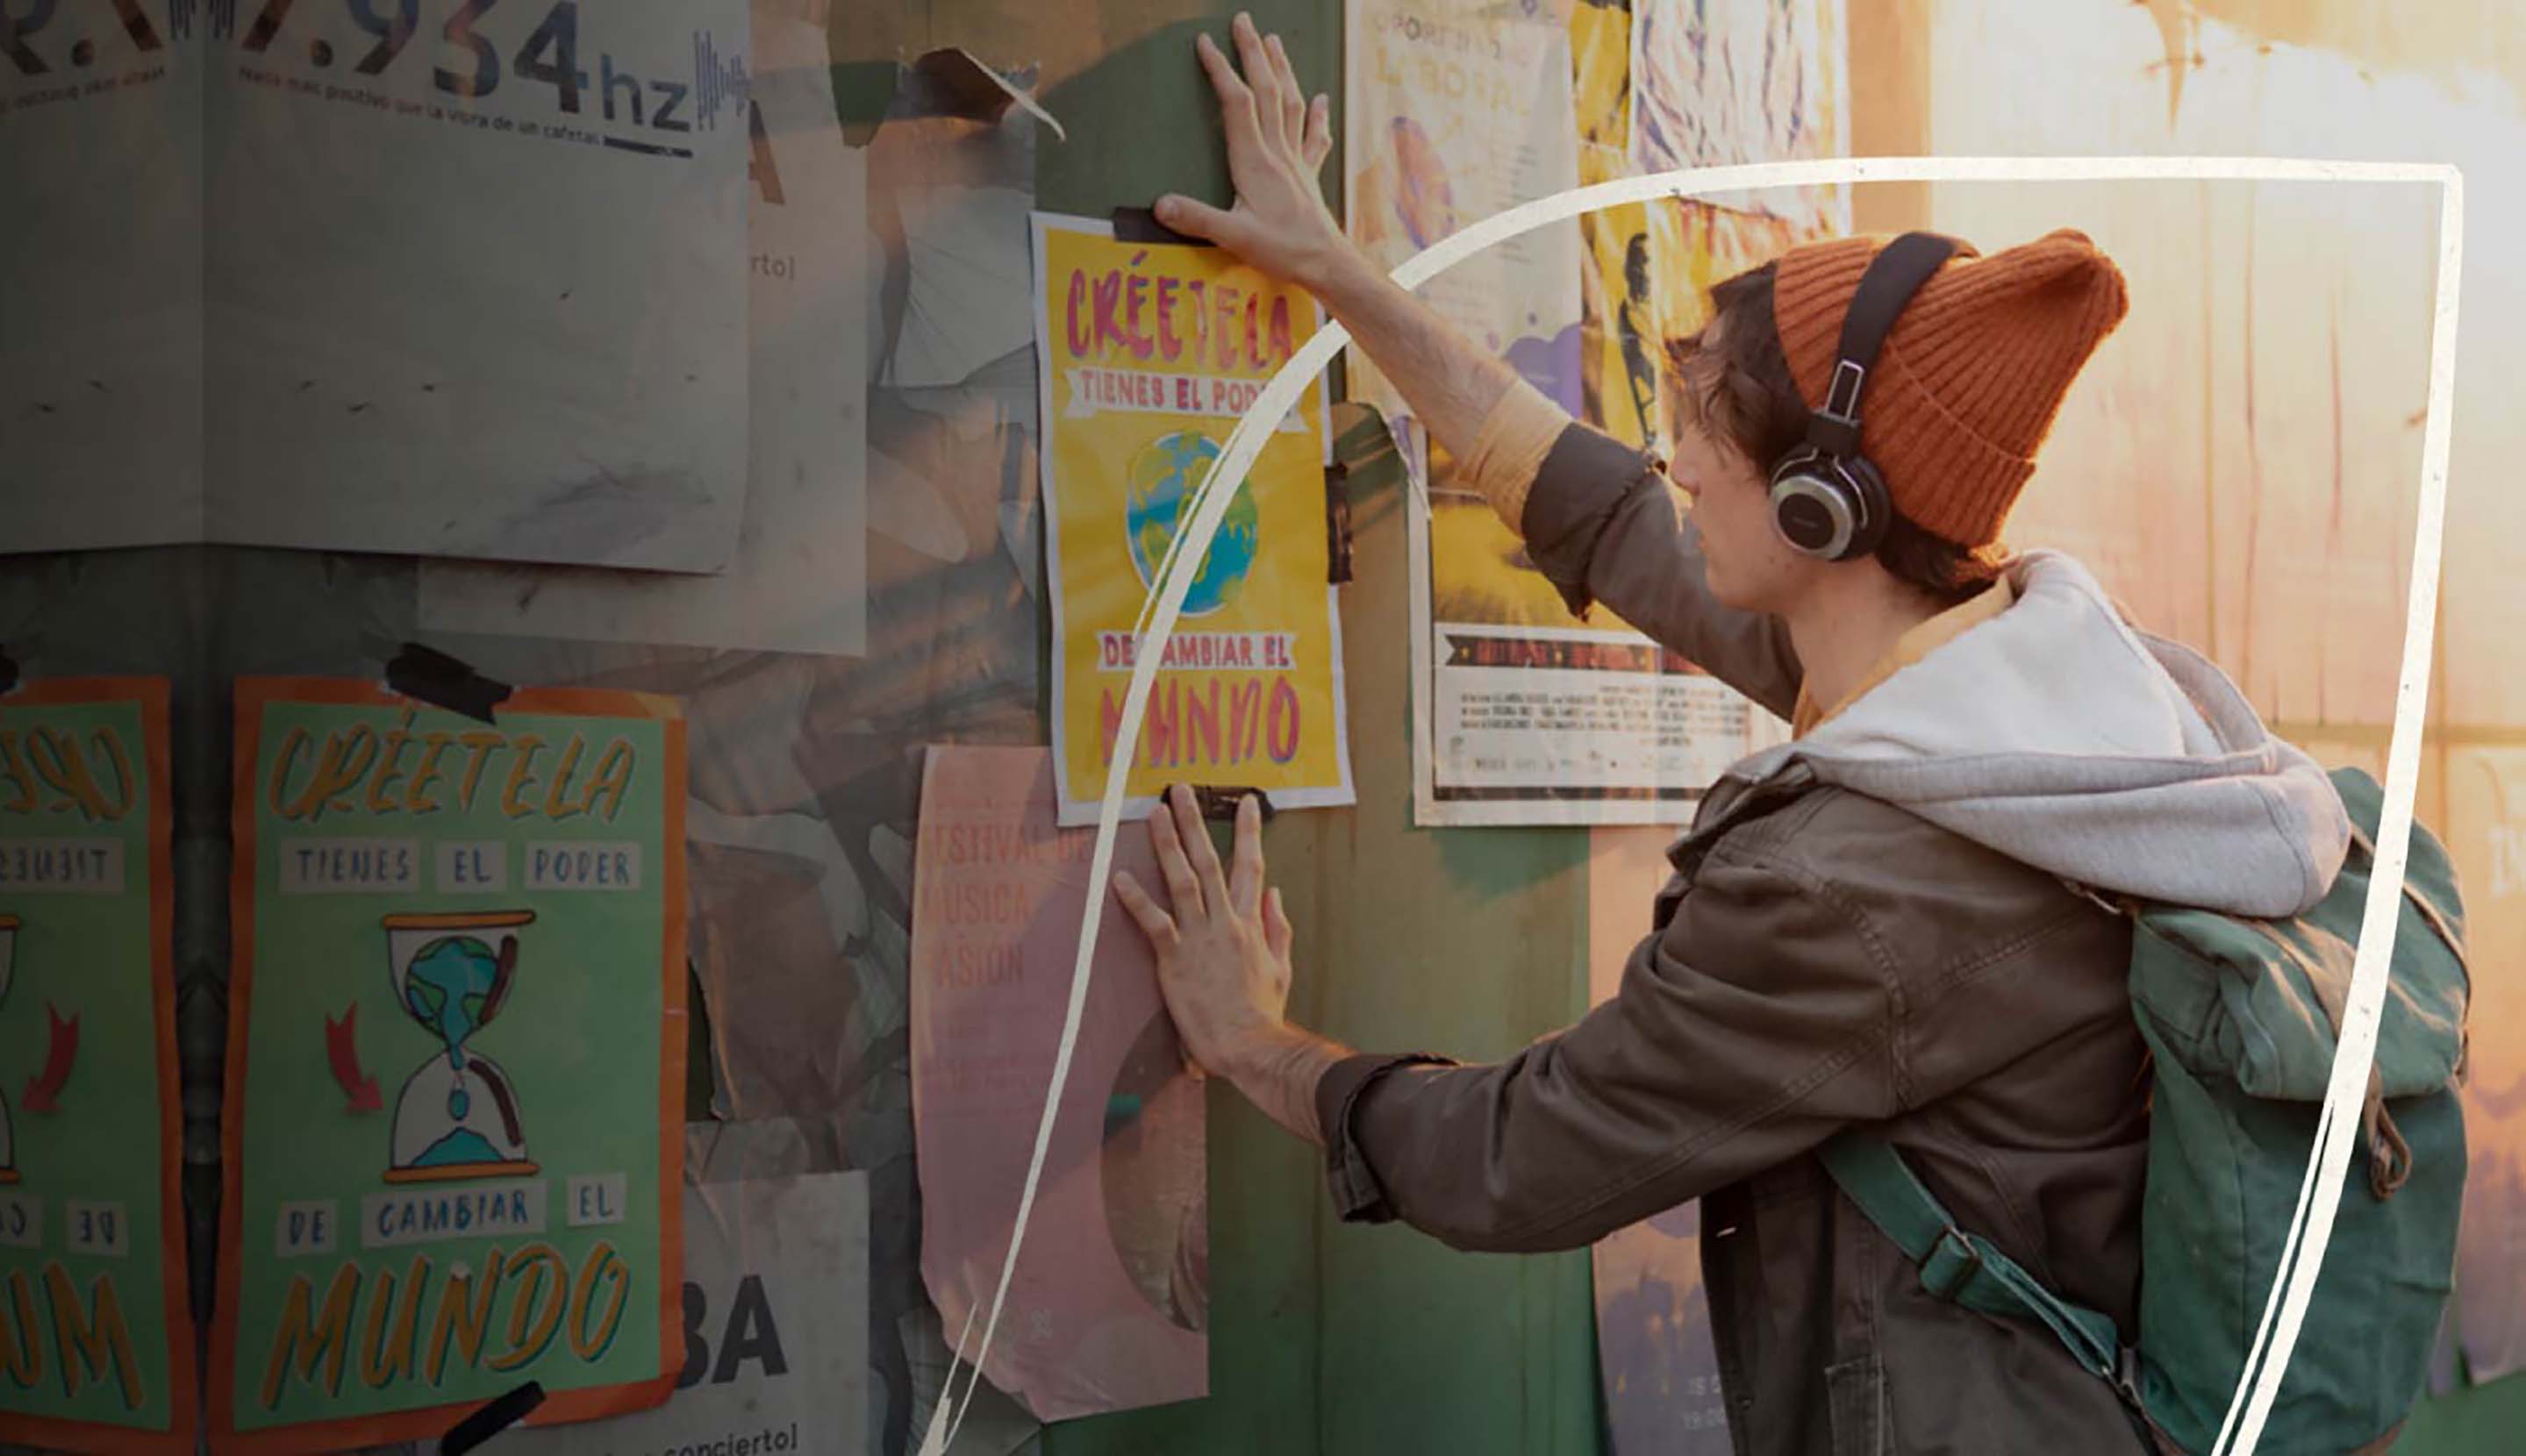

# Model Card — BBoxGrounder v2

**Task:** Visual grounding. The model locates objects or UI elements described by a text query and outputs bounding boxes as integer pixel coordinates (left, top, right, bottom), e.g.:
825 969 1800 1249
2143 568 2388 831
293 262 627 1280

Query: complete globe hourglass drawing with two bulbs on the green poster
384 911 535 1183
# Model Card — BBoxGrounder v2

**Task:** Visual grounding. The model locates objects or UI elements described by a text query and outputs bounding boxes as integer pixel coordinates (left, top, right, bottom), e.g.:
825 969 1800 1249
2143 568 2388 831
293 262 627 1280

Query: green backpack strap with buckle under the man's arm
1816 1131 2140 1408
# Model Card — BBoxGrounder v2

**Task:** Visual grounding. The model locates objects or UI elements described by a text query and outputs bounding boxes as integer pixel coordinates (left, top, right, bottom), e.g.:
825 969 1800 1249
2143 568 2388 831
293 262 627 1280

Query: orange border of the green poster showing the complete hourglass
207 676 687 1456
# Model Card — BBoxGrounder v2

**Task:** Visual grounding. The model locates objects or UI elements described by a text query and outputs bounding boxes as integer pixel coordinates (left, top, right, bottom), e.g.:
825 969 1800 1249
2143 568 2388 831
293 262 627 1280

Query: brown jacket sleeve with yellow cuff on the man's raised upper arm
1465 381 1806 719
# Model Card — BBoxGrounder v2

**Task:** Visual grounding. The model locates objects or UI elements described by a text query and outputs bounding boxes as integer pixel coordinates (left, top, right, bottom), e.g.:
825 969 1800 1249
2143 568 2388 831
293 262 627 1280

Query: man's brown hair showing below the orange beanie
1667 262 2008 605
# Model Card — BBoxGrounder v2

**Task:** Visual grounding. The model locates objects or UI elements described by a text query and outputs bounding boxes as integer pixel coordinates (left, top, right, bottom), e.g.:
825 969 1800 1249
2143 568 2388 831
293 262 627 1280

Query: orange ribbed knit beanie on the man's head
1771 227 2127 547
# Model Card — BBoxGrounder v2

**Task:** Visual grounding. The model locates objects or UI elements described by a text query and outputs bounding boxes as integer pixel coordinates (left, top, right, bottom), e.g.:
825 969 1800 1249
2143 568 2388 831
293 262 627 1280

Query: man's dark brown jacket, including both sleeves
1316 426 2147 1456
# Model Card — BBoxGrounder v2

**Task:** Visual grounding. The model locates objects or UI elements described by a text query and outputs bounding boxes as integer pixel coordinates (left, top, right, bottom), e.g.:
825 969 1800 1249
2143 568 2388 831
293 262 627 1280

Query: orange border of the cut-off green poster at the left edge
0 676 202 1456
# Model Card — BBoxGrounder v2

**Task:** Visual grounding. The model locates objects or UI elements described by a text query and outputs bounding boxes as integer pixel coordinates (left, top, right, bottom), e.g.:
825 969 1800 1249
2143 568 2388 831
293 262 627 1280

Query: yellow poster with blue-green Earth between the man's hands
1034 212 1351 825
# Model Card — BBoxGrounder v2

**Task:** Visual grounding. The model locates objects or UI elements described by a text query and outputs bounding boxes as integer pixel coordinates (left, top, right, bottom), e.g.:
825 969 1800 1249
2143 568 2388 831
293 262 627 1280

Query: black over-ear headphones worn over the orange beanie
1771 232 1957 560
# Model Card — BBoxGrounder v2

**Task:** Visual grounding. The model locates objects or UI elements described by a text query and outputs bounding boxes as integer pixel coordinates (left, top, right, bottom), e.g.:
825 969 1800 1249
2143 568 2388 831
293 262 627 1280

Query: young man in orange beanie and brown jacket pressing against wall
1117 18 2349 1456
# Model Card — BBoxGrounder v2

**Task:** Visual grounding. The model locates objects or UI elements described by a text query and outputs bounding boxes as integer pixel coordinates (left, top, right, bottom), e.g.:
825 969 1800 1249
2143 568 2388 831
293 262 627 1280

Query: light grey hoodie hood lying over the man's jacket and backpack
1730 550 2349 918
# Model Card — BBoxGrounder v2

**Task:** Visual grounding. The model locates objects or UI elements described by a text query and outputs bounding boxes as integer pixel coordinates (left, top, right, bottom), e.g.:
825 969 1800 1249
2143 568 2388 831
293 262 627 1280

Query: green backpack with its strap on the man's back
1819 769 2471 1453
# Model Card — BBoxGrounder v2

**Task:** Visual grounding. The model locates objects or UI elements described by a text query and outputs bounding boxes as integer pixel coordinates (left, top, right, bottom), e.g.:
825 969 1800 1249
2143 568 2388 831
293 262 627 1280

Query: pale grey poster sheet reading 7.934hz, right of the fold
199 0 750 570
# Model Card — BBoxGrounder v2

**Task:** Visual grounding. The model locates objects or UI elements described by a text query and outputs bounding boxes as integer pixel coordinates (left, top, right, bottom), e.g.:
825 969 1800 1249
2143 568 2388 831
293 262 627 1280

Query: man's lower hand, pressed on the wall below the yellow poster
1114 785 1291 1077
